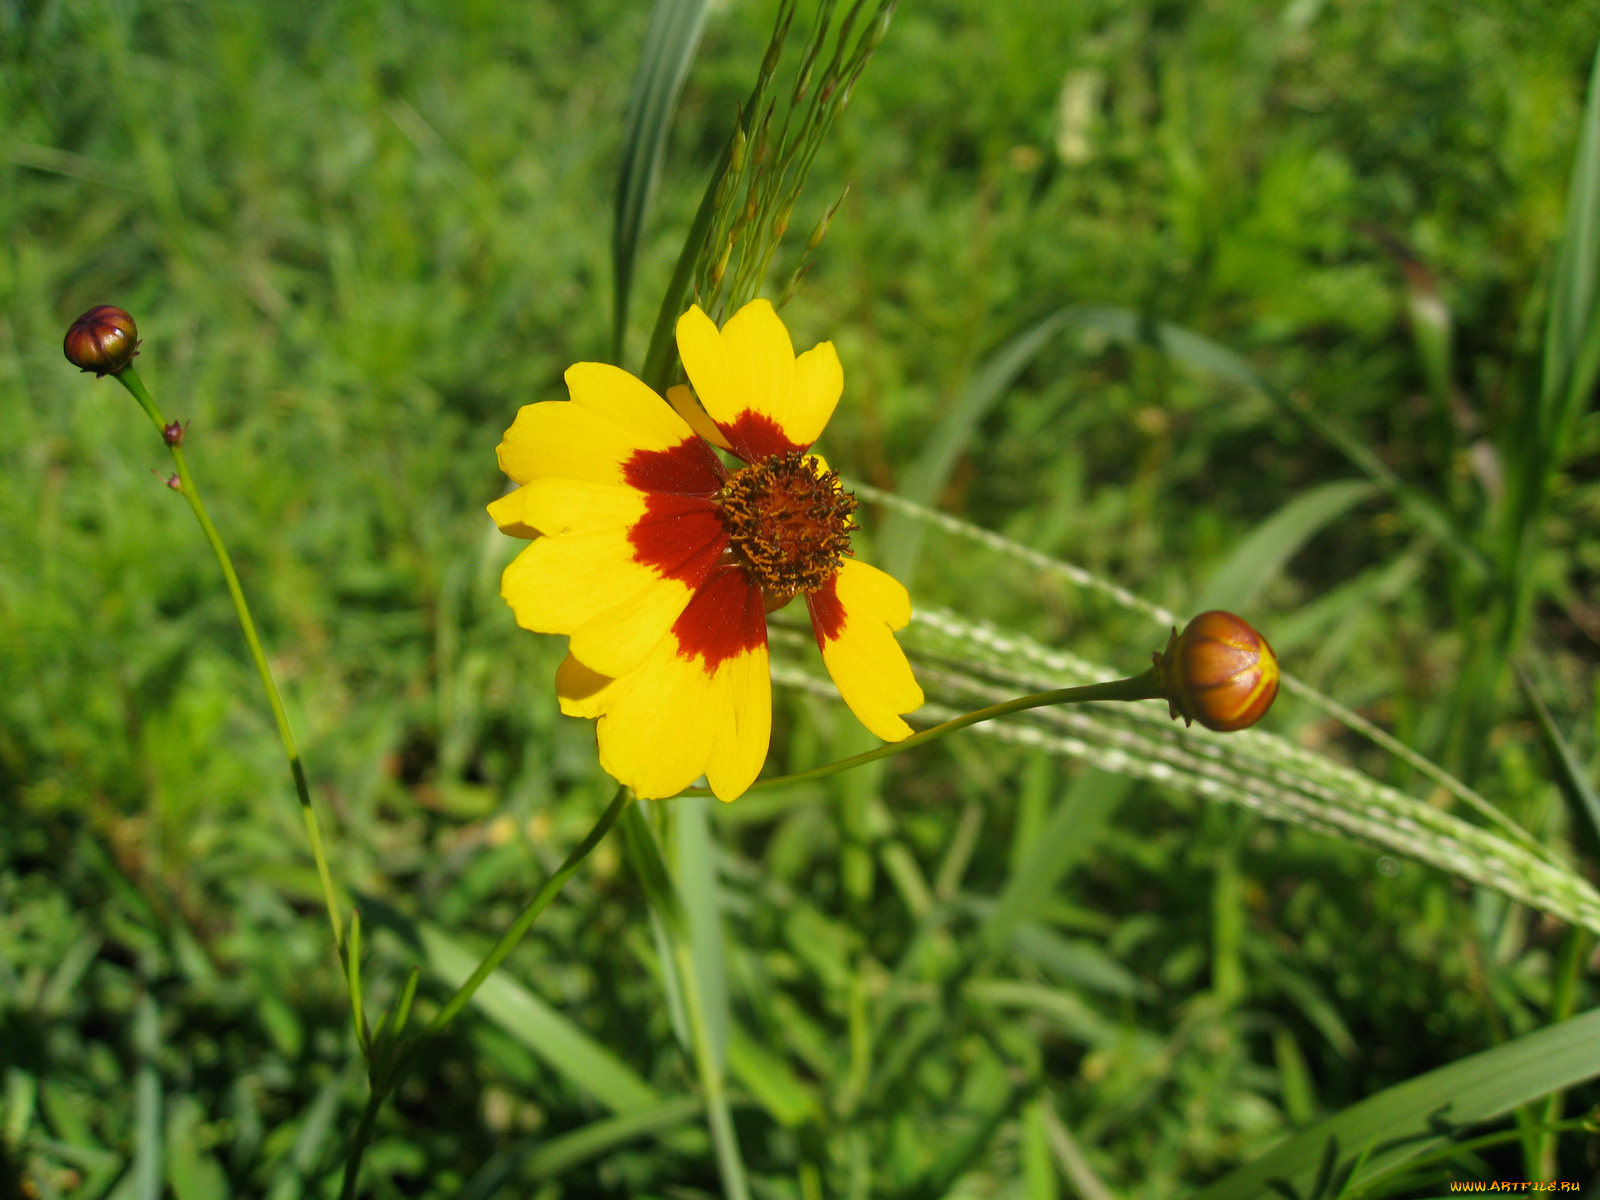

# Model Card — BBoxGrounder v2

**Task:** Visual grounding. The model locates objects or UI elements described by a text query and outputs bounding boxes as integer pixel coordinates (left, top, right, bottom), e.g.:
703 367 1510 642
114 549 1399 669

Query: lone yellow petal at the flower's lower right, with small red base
806 558 923 742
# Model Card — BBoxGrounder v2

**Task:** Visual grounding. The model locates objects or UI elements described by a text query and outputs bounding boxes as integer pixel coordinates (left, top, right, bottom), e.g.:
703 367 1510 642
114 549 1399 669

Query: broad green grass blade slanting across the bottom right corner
1195 1010 1600 1200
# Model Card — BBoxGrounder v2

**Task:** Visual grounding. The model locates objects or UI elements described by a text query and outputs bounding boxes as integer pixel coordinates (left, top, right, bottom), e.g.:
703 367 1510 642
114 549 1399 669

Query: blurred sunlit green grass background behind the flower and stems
0 0 1600 1200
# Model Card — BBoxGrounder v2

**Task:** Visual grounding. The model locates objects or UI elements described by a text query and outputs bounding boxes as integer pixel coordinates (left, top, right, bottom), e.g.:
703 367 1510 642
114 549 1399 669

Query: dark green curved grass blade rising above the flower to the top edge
611 0 710 365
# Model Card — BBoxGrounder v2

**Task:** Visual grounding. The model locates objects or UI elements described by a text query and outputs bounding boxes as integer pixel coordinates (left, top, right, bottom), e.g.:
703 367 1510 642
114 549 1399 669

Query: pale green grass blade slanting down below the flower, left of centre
416 922 658 1112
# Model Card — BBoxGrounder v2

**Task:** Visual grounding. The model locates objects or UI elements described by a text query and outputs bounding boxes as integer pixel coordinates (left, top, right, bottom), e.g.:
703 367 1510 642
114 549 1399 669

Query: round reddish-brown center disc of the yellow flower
717 450 856 611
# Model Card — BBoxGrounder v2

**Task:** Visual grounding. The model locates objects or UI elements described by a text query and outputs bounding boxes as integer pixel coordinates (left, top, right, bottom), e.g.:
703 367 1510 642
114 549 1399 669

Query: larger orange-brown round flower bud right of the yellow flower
1154 610 1278 733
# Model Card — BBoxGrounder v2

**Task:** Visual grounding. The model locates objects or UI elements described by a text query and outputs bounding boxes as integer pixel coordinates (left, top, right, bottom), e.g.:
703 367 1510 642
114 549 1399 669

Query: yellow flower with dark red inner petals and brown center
490 301 923 800
